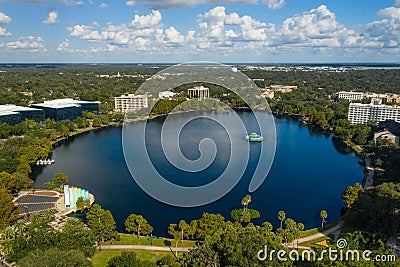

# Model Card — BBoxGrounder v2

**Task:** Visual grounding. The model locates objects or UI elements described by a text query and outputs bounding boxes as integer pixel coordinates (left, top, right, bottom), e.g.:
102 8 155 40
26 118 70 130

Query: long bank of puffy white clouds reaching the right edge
64 4 400 55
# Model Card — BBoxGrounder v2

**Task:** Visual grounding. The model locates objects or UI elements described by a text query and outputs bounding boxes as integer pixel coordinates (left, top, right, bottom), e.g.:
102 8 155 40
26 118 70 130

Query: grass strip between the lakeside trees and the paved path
103 233 196 248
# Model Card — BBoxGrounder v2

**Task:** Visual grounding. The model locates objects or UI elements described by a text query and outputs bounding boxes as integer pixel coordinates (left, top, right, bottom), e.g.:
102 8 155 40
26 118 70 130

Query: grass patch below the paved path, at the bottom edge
92 250 182 267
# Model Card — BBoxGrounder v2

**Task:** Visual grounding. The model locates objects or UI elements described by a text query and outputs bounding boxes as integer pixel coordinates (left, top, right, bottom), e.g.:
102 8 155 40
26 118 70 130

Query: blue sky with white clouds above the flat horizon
0 0 400 63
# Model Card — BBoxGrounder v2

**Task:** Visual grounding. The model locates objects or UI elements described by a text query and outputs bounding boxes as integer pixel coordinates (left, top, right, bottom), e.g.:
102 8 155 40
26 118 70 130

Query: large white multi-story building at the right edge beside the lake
348 99 400 124
